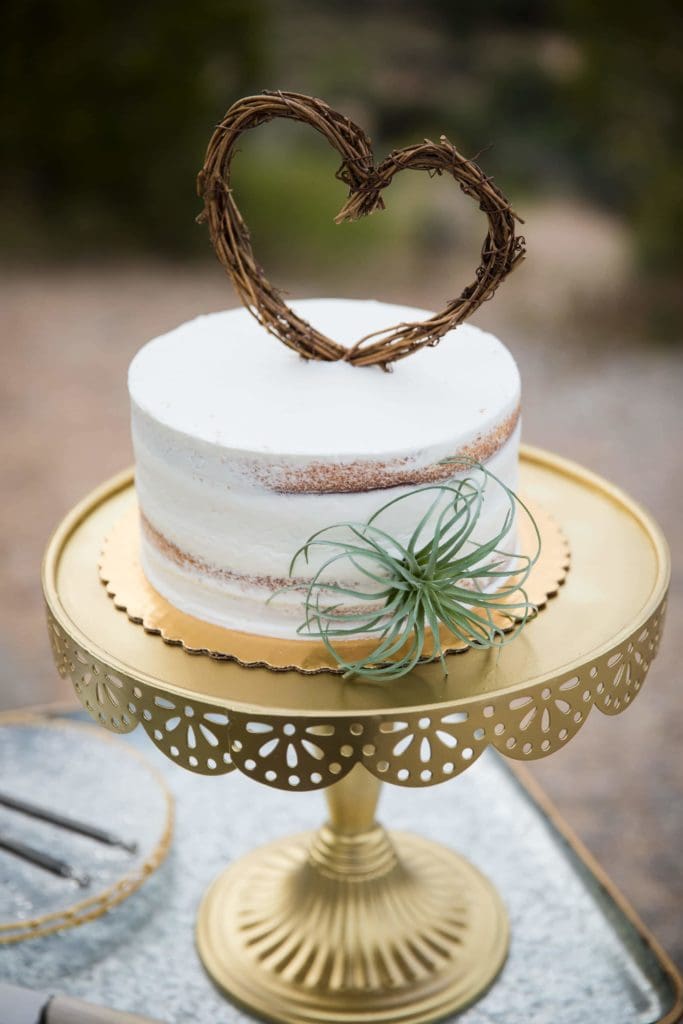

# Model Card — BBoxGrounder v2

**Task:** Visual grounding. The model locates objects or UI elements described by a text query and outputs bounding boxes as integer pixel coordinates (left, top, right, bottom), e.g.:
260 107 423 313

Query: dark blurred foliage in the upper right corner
566 0 683 272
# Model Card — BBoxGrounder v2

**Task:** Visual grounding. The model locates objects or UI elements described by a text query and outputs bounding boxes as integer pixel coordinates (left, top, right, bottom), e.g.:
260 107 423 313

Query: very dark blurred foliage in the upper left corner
0 0 264 255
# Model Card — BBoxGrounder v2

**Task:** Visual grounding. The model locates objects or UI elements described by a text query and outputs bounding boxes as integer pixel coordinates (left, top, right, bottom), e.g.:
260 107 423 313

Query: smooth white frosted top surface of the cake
128 299 520 458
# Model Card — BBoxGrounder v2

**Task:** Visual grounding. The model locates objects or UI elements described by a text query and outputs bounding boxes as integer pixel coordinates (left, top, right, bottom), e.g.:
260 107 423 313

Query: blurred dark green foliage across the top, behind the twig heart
0 0 683 272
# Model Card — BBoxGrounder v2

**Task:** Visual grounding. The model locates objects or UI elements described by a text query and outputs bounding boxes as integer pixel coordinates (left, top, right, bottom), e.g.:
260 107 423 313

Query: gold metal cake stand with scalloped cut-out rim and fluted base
43 449 669 1024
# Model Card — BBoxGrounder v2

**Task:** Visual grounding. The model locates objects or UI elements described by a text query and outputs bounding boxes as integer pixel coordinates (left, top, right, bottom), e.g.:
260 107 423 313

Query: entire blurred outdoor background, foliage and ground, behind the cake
0 0 683 963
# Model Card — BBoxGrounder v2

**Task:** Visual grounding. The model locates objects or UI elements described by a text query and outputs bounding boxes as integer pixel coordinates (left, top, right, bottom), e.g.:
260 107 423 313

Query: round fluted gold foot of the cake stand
197 825 508 1024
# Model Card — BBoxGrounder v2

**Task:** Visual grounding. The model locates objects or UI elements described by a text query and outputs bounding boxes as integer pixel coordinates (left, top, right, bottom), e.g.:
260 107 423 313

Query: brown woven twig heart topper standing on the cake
198 92 524 367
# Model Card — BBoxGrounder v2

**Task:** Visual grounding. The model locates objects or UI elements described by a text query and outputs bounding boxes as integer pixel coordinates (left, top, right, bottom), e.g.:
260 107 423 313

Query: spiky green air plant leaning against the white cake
274 458 541 681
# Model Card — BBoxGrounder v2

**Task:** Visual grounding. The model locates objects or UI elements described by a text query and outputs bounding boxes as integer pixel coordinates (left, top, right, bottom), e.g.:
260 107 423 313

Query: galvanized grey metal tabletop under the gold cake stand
0 716 683 1024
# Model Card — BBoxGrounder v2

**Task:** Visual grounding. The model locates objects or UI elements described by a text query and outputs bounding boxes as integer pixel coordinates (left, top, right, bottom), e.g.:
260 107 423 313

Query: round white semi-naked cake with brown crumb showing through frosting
129 299 520 638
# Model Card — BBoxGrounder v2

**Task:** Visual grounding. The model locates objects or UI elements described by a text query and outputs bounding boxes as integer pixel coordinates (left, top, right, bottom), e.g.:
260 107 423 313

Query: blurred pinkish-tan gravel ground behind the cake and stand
0 209 683 964
